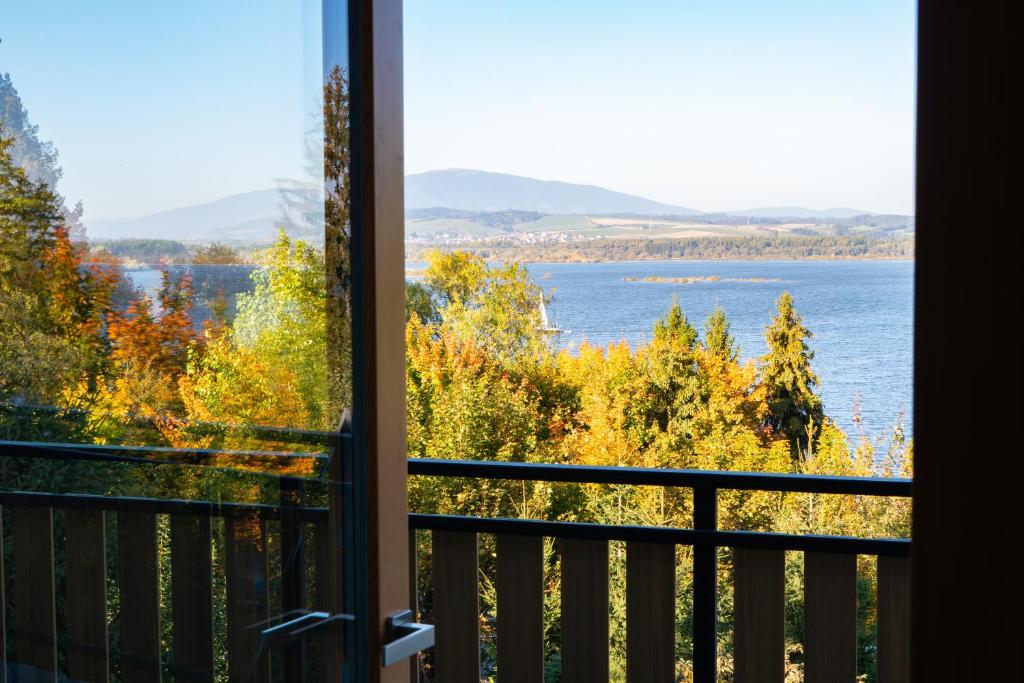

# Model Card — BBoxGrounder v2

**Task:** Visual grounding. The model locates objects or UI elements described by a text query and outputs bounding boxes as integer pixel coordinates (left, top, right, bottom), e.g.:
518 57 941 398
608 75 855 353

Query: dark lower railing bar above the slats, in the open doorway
409 513 910 557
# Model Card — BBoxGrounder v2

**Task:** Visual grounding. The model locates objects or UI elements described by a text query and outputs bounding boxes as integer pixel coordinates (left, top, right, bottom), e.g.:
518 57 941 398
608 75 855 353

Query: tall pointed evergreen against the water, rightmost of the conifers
760 292 823 459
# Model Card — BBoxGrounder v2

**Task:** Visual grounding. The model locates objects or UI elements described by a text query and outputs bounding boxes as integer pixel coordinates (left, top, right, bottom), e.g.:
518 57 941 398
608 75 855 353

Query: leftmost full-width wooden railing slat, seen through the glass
11 508 57 681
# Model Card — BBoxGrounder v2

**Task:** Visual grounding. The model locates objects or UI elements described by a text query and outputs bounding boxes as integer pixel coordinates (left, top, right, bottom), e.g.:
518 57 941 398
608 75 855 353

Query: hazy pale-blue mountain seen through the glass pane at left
88 189 282 241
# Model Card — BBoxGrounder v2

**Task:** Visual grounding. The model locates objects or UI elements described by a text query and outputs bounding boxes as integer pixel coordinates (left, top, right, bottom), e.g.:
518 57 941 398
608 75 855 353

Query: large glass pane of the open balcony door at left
0 0 351 681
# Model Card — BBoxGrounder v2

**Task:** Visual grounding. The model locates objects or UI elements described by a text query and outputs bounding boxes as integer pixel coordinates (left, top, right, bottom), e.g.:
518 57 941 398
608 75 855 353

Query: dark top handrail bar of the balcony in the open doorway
409 458 912 498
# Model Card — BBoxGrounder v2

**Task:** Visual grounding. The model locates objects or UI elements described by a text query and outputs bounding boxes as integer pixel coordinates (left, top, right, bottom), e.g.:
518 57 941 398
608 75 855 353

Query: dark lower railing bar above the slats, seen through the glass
0 490 327 523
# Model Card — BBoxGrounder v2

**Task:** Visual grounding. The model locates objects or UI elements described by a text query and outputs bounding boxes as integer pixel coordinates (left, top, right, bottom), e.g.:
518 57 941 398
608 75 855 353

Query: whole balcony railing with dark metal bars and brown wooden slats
0 439 910 683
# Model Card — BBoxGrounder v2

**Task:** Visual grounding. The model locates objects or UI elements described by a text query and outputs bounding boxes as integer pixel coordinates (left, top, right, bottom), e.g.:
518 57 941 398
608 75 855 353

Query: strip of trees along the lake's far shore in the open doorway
407 236 914 263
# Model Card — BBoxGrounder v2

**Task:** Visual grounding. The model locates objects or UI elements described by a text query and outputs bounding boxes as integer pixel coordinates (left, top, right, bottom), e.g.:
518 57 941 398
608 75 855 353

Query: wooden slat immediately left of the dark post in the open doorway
626 542 676 683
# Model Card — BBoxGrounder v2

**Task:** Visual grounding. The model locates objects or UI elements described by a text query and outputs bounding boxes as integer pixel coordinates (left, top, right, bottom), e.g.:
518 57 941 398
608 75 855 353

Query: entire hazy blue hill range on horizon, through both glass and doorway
87 169 892 244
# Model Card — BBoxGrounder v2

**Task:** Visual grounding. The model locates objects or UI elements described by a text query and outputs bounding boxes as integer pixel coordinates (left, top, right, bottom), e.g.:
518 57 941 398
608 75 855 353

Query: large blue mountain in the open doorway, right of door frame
406 169 700 215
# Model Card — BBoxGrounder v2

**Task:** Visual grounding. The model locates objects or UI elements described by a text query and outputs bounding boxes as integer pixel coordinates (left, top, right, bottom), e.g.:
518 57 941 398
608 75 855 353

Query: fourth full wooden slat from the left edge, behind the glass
170 514 213 683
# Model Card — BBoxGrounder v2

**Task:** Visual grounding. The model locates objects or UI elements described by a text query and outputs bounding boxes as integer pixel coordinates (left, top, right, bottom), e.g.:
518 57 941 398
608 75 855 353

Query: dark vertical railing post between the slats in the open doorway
693 486 718 683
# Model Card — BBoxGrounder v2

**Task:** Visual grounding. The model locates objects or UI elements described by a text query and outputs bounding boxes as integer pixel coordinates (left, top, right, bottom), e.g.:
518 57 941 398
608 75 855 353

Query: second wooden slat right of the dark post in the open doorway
804 553 857 683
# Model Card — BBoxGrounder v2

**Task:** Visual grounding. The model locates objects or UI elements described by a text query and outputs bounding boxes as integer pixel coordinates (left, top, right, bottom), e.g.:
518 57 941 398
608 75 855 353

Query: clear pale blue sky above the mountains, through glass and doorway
0 0 915 220
